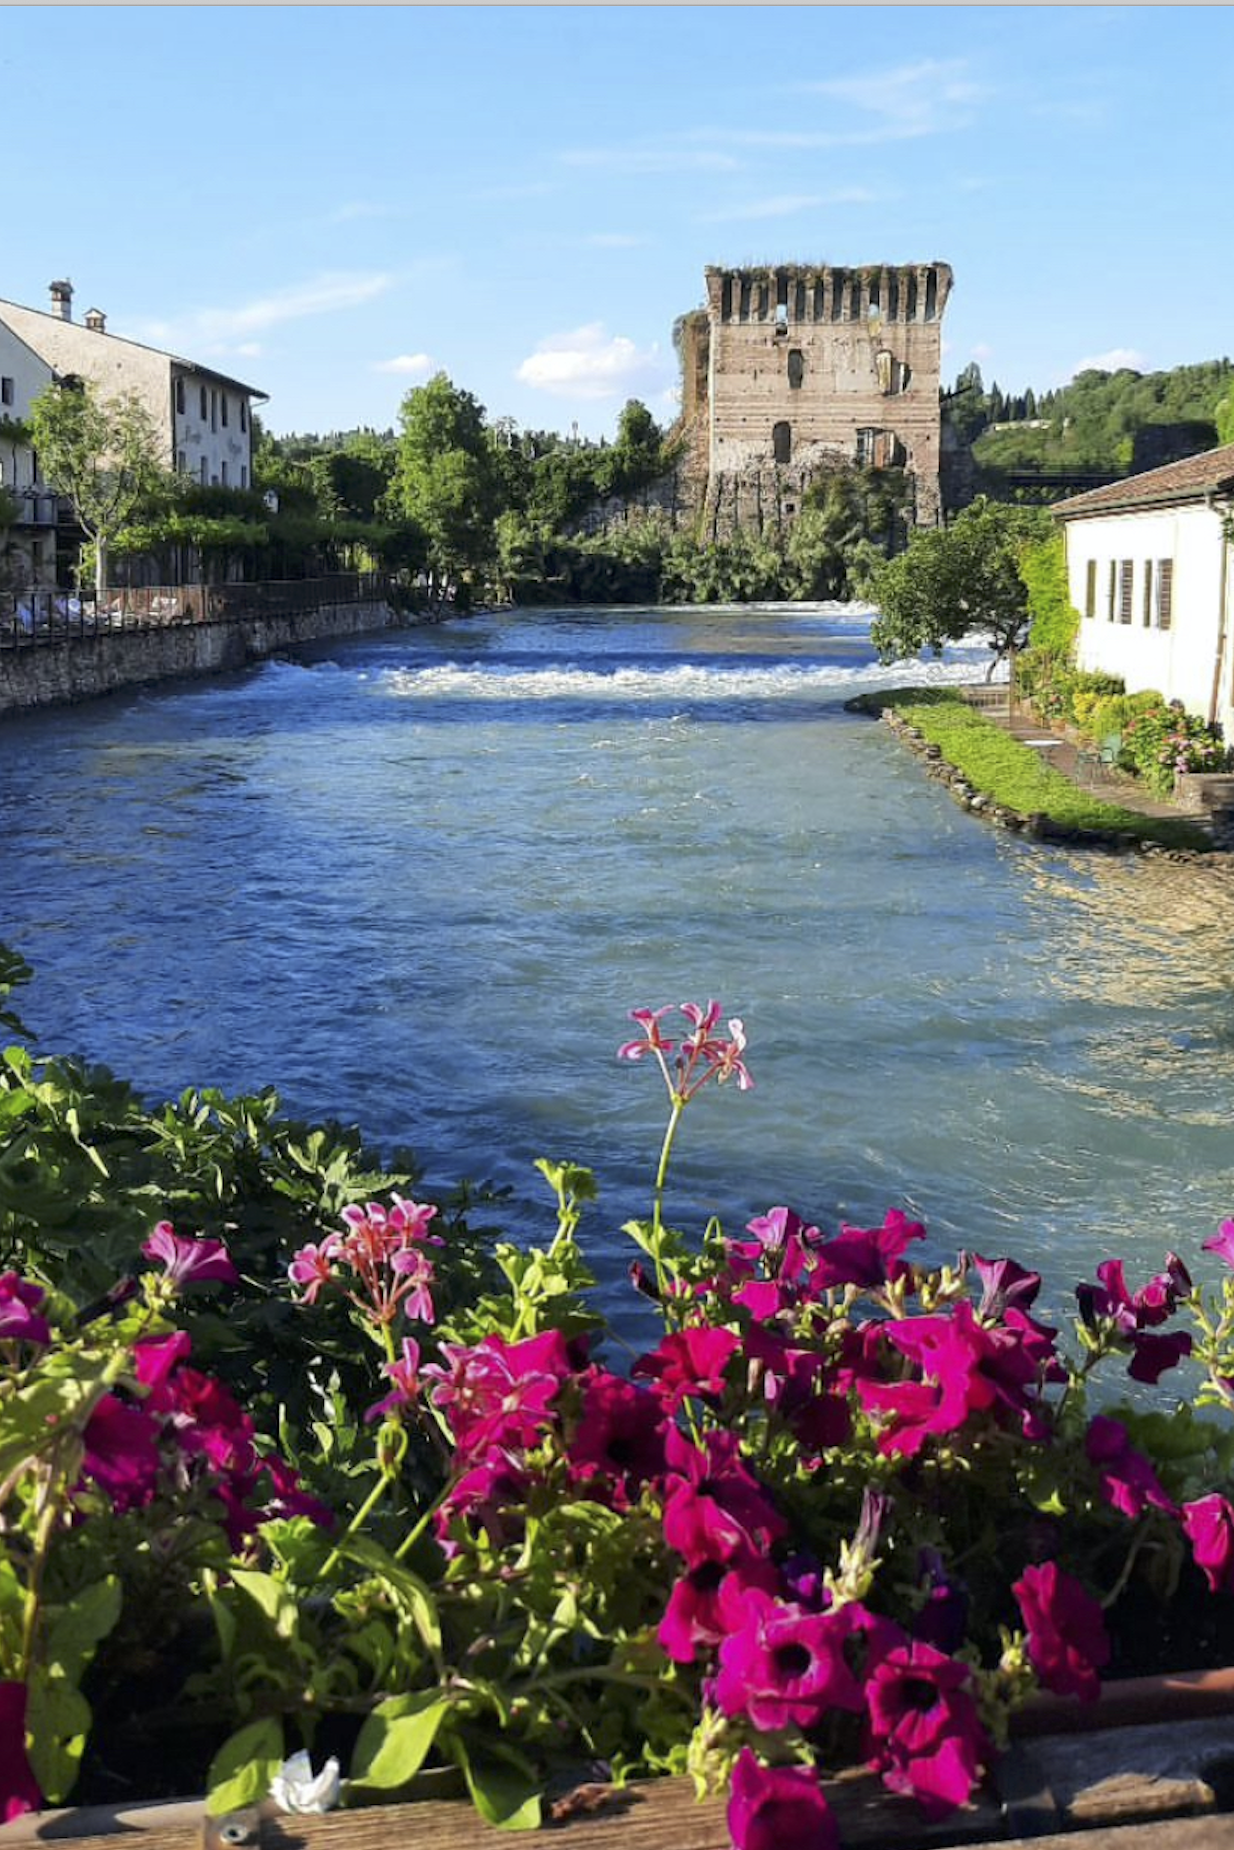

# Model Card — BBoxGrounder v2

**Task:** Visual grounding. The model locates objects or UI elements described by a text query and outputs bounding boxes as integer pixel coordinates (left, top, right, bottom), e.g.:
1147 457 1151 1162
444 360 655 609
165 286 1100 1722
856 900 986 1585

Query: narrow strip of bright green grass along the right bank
877 688 1212 851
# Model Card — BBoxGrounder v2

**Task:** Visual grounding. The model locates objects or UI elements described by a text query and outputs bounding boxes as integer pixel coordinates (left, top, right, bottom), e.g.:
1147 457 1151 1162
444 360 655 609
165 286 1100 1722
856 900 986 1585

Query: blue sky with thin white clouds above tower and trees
0 4 1234 437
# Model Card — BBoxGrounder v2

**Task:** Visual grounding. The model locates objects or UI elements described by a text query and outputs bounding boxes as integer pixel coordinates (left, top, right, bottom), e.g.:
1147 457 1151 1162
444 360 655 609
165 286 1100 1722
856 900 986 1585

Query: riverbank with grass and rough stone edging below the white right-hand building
849 688 1215 858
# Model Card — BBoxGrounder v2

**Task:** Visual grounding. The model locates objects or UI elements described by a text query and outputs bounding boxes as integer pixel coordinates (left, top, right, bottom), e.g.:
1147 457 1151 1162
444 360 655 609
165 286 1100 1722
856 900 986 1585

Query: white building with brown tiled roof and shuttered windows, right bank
1053 444 1234 740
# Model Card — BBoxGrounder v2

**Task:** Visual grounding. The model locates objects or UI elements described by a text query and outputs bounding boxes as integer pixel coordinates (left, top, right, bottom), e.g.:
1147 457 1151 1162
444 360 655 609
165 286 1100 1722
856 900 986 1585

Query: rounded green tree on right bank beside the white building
870 498 1051 673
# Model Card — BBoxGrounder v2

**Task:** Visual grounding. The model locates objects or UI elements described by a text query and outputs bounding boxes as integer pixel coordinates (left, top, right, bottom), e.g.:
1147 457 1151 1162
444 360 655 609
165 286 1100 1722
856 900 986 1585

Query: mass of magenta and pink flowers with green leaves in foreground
0 1003 1234 1850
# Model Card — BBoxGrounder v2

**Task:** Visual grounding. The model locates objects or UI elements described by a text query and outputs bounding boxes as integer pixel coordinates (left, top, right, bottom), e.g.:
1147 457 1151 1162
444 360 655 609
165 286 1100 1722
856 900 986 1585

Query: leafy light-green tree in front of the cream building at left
30 383 170 598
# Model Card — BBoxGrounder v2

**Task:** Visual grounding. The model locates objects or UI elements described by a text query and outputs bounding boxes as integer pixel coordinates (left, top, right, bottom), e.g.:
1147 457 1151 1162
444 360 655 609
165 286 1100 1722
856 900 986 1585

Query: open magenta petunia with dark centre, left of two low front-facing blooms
712 1587 862 1732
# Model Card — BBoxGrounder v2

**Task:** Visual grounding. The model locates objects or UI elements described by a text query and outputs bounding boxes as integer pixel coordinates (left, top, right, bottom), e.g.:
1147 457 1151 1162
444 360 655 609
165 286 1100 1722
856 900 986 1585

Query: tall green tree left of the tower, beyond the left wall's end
390 372 501 596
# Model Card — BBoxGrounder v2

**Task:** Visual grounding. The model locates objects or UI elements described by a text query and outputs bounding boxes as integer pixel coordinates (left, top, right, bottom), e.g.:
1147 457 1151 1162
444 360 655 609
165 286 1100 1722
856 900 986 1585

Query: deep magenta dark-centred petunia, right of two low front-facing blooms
866 1641 992 1819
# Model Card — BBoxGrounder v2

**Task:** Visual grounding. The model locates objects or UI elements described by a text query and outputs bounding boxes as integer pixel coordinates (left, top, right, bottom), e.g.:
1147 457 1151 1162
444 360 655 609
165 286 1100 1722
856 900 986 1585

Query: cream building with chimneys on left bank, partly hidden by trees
0 283 266 583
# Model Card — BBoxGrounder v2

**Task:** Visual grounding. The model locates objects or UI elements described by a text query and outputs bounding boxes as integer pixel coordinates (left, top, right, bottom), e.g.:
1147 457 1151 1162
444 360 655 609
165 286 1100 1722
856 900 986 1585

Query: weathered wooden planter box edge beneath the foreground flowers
0 1672 1234 1850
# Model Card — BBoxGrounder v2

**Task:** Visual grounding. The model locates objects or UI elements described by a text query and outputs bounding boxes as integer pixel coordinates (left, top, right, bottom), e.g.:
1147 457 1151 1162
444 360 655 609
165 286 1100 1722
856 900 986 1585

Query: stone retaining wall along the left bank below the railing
0 603 400 718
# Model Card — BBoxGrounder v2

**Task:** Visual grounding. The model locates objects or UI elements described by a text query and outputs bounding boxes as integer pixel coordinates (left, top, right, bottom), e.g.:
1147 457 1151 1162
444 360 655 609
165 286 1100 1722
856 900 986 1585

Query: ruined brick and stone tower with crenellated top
679 263 951 538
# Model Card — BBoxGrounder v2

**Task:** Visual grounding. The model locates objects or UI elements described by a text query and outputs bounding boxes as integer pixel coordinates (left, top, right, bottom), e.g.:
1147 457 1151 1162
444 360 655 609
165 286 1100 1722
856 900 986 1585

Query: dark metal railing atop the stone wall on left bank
0 572 394 649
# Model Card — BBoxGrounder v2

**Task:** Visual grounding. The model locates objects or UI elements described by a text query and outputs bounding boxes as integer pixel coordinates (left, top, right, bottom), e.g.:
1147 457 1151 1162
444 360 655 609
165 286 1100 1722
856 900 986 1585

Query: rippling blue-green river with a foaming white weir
0 605 1234 1346
